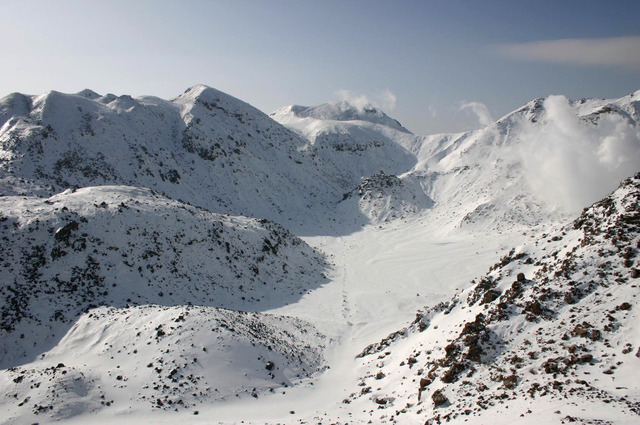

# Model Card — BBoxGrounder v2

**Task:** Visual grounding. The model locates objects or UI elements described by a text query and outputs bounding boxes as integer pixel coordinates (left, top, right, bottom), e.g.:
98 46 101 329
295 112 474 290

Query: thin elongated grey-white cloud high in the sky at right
496 36 640 71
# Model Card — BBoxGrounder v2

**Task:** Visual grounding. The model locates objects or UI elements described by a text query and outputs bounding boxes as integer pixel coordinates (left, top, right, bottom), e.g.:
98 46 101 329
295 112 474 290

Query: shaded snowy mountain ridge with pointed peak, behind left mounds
0 86 348 232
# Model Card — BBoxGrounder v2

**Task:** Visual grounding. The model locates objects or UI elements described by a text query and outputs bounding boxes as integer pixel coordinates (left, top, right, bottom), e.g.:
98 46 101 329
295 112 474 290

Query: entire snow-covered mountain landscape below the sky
0 86 640 424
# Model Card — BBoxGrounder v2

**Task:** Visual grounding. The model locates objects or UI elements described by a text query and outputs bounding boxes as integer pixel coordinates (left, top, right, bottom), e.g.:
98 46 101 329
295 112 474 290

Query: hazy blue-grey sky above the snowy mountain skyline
0 0 640 134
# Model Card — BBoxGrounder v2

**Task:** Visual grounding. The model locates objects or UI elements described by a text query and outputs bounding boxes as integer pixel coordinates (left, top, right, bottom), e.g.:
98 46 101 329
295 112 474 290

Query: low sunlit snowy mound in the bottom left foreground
0 305 325 423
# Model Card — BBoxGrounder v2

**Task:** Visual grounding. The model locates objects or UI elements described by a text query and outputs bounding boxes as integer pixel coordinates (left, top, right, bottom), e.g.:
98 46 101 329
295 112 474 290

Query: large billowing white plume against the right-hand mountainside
520 96 640 212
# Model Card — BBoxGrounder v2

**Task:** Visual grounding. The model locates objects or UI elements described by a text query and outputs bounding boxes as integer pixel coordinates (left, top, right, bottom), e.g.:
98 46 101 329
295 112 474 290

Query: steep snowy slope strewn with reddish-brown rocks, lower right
345 174 640 424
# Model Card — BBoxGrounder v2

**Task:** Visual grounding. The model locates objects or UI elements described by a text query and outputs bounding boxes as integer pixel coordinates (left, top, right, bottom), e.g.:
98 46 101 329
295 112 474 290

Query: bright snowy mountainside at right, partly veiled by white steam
403 91 640 231
